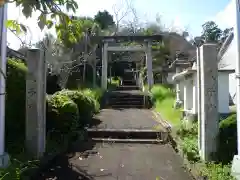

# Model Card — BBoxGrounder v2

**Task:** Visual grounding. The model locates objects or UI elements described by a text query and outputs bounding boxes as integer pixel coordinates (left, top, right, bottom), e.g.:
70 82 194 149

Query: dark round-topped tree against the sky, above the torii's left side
94 10 115 29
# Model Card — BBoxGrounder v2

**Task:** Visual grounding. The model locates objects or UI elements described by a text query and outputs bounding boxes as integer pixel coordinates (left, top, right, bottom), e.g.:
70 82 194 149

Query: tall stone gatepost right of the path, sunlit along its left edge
200 44 219 161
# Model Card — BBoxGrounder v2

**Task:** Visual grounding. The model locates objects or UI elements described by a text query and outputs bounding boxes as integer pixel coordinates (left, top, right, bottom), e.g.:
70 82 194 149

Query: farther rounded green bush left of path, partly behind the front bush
56 90 99 125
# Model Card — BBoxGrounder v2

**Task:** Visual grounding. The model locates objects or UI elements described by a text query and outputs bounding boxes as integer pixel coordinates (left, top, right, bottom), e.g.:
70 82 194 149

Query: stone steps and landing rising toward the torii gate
87 75 168 144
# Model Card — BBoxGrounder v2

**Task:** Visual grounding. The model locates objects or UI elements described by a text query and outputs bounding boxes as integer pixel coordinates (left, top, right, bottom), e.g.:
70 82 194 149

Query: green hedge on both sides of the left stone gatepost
6 59 102 144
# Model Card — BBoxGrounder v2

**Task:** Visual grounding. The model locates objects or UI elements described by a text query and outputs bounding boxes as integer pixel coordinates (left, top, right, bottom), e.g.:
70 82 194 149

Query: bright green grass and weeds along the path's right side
151 85 236 180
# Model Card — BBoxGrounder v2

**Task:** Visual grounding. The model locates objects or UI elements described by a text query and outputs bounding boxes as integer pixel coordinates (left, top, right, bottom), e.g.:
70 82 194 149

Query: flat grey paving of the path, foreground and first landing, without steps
34 90 193 180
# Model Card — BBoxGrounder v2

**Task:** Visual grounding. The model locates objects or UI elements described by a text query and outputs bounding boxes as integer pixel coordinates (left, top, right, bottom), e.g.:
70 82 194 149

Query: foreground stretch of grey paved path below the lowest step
38 142 193 180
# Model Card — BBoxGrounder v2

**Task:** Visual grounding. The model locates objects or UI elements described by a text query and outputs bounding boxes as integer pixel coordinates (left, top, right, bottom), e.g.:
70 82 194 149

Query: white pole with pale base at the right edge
232 0 240 180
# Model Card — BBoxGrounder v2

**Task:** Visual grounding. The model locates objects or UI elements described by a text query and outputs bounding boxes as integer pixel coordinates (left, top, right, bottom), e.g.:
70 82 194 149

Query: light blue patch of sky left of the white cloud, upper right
133 0 230 35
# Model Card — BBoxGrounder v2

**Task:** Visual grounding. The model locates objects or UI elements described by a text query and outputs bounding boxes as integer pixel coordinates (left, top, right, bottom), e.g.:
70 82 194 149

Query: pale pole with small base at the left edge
0 3 9 168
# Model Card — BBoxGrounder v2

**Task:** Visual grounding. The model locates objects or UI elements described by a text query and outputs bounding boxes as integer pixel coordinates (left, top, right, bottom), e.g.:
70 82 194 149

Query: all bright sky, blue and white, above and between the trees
8 0 234 49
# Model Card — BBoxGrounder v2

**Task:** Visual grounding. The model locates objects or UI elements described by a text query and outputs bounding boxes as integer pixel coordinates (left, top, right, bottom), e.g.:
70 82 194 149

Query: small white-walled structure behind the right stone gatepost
172 64 234 119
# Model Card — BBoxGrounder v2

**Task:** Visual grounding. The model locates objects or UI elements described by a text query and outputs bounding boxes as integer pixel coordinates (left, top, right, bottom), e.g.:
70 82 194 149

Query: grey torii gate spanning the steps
98 35 162 89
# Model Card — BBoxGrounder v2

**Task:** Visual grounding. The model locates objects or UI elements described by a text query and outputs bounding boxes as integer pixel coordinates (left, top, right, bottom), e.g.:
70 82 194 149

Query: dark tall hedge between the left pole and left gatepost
6 59 27 144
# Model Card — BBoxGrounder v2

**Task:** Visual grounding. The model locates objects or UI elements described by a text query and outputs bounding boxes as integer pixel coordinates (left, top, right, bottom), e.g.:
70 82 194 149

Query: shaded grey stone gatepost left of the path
26 49 46 158
